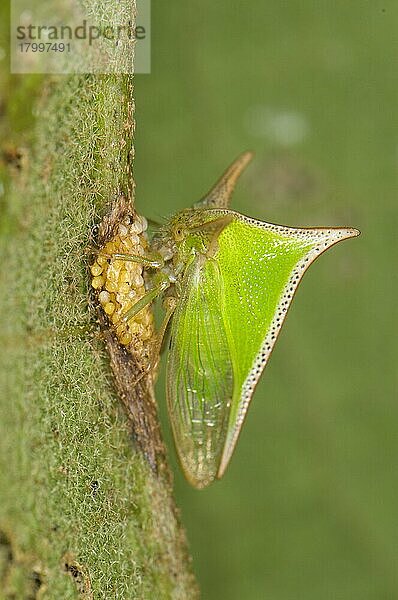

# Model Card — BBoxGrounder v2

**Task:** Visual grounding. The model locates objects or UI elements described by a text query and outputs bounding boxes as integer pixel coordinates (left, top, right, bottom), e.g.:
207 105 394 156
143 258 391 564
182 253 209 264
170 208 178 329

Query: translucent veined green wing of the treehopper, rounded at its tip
167 256 233 488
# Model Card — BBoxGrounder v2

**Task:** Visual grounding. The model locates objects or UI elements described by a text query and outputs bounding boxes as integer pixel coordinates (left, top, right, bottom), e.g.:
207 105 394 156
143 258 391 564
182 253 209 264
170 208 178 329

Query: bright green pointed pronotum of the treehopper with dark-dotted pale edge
214 211 359 478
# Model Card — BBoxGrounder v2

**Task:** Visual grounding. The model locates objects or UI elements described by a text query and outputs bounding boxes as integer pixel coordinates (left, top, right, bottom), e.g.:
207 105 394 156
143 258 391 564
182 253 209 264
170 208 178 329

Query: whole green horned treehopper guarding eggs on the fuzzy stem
92 152 359 488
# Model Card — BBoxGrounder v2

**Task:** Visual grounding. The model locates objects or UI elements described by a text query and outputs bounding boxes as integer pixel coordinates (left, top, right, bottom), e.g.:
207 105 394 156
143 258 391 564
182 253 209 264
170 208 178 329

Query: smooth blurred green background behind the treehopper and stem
135 0 398 600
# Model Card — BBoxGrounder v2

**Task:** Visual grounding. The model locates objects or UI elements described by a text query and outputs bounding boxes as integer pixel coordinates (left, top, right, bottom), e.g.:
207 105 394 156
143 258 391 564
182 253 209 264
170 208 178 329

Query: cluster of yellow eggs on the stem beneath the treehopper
91 216 154 352
